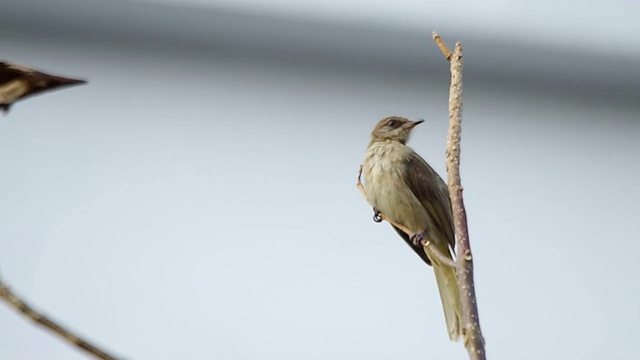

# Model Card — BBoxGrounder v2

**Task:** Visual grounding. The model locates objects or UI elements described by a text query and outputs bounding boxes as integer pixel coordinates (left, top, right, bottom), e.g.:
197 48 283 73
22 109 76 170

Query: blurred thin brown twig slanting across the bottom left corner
0 279 122 360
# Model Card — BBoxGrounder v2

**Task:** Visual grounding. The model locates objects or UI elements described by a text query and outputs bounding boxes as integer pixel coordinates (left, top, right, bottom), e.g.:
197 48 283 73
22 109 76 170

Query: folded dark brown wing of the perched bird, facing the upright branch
403 151 455 250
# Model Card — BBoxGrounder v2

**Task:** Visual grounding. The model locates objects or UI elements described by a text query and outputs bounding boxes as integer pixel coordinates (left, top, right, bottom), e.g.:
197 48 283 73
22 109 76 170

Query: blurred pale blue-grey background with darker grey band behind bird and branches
0 0 640 359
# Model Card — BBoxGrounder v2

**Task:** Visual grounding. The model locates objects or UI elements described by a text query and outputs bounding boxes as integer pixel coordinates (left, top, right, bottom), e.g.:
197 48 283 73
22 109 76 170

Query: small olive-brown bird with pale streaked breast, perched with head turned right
362 116 462 341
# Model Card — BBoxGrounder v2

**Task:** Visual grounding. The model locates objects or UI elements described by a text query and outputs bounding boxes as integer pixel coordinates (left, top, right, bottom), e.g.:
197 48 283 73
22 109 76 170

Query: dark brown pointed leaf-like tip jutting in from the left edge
0 61 86 113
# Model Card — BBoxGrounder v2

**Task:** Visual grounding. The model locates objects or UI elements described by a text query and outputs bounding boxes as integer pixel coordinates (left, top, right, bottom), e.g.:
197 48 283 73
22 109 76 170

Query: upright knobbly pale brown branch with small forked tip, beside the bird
434 33 486 360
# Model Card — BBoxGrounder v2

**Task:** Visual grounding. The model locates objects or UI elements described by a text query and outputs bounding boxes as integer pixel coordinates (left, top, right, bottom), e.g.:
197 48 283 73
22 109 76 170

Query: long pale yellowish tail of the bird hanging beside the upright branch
432 249 462 341
